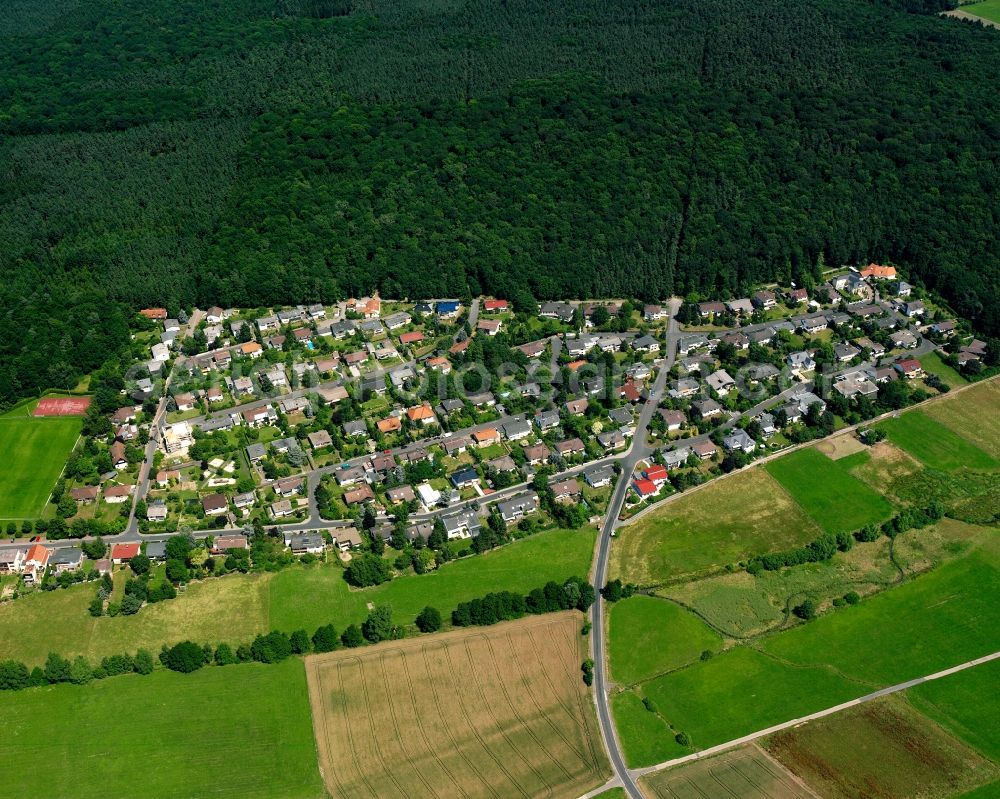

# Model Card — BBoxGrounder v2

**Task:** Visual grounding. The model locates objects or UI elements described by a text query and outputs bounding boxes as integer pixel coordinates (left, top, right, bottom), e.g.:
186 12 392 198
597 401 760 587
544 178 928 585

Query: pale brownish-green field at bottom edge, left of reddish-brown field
639 746 815 799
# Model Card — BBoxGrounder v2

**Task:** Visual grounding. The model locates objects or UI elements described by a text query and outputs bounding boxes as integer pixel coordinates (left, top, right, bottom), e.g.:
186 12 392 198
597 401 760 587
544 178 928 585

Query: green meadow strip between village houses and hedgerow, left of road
269 527 596 633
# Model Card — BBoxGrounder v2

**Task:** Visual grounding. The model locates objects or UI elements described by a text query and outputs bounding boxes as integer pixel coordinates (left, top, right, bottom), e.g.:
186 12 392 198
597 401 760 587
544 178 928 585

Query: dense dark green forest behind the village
0 0 1000 402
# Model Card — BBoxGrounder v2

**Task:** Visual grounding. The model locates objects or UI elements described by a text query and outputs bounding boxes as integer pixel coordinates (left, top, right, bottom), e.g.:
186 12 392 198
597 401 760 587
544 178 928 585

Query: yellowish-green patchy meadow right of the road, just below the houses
610 468 824 585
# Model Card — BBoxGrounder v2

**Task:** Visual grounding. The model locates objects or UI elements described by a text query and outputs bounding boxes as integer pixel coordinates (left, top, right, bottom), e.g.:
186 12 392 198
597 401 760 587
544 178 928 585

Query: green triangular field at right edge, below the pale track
906 660 1000 763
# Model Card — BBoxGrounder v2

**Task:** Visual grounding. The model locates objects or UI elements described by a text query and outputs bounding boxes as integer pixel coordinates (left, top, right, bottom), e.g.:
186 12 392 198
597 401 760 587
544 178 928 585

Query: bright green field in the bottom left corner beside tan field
0 658 325 799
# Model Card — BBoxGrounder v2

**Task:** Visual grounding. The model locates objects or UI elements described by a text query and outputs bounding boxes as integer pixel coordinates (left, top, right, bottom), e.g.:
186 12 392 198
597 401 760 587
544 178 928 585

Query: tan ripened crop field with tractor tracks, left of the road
306 612 610 799
